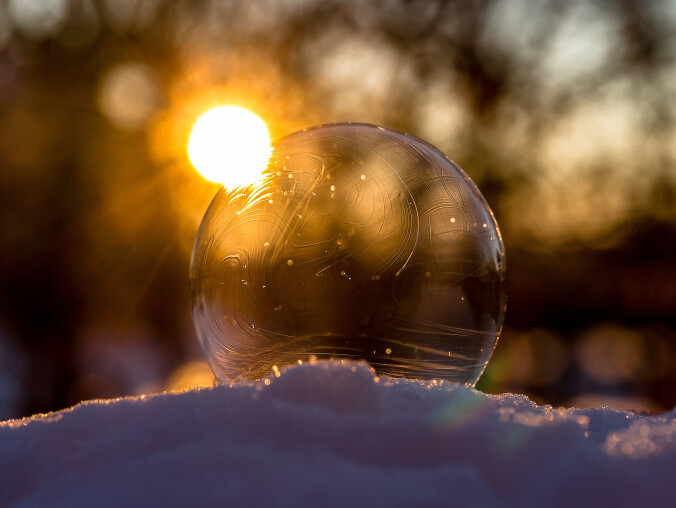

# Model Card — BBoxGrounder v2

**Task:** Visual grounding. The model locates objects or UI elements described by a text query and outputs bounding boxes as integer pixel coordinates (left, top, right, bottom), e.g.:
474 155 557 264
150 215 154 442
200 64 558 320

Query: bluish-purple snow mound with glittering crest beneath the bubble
0 362 676 506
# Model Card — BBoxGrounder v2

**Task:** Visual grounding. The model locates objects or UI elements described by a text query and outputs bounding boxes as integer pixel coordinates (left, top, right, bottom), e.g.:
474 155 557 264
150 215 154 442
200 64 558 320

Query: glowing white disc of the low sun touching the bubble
188 106 271 189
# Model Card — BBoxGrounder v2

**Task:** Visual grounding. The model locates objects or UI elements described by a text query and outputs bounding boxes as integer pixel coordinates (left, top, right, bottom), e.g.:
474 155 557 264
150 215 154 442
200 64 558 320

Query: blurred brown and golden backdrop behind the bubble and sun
0 0 676 420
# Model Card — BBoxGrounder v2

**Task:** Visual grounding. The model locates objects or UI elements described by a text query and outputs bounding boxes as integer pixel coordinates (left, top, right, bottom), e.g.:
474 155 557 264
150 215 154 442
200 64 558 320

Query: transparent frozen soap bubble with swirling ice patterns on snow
190 124 506 384
